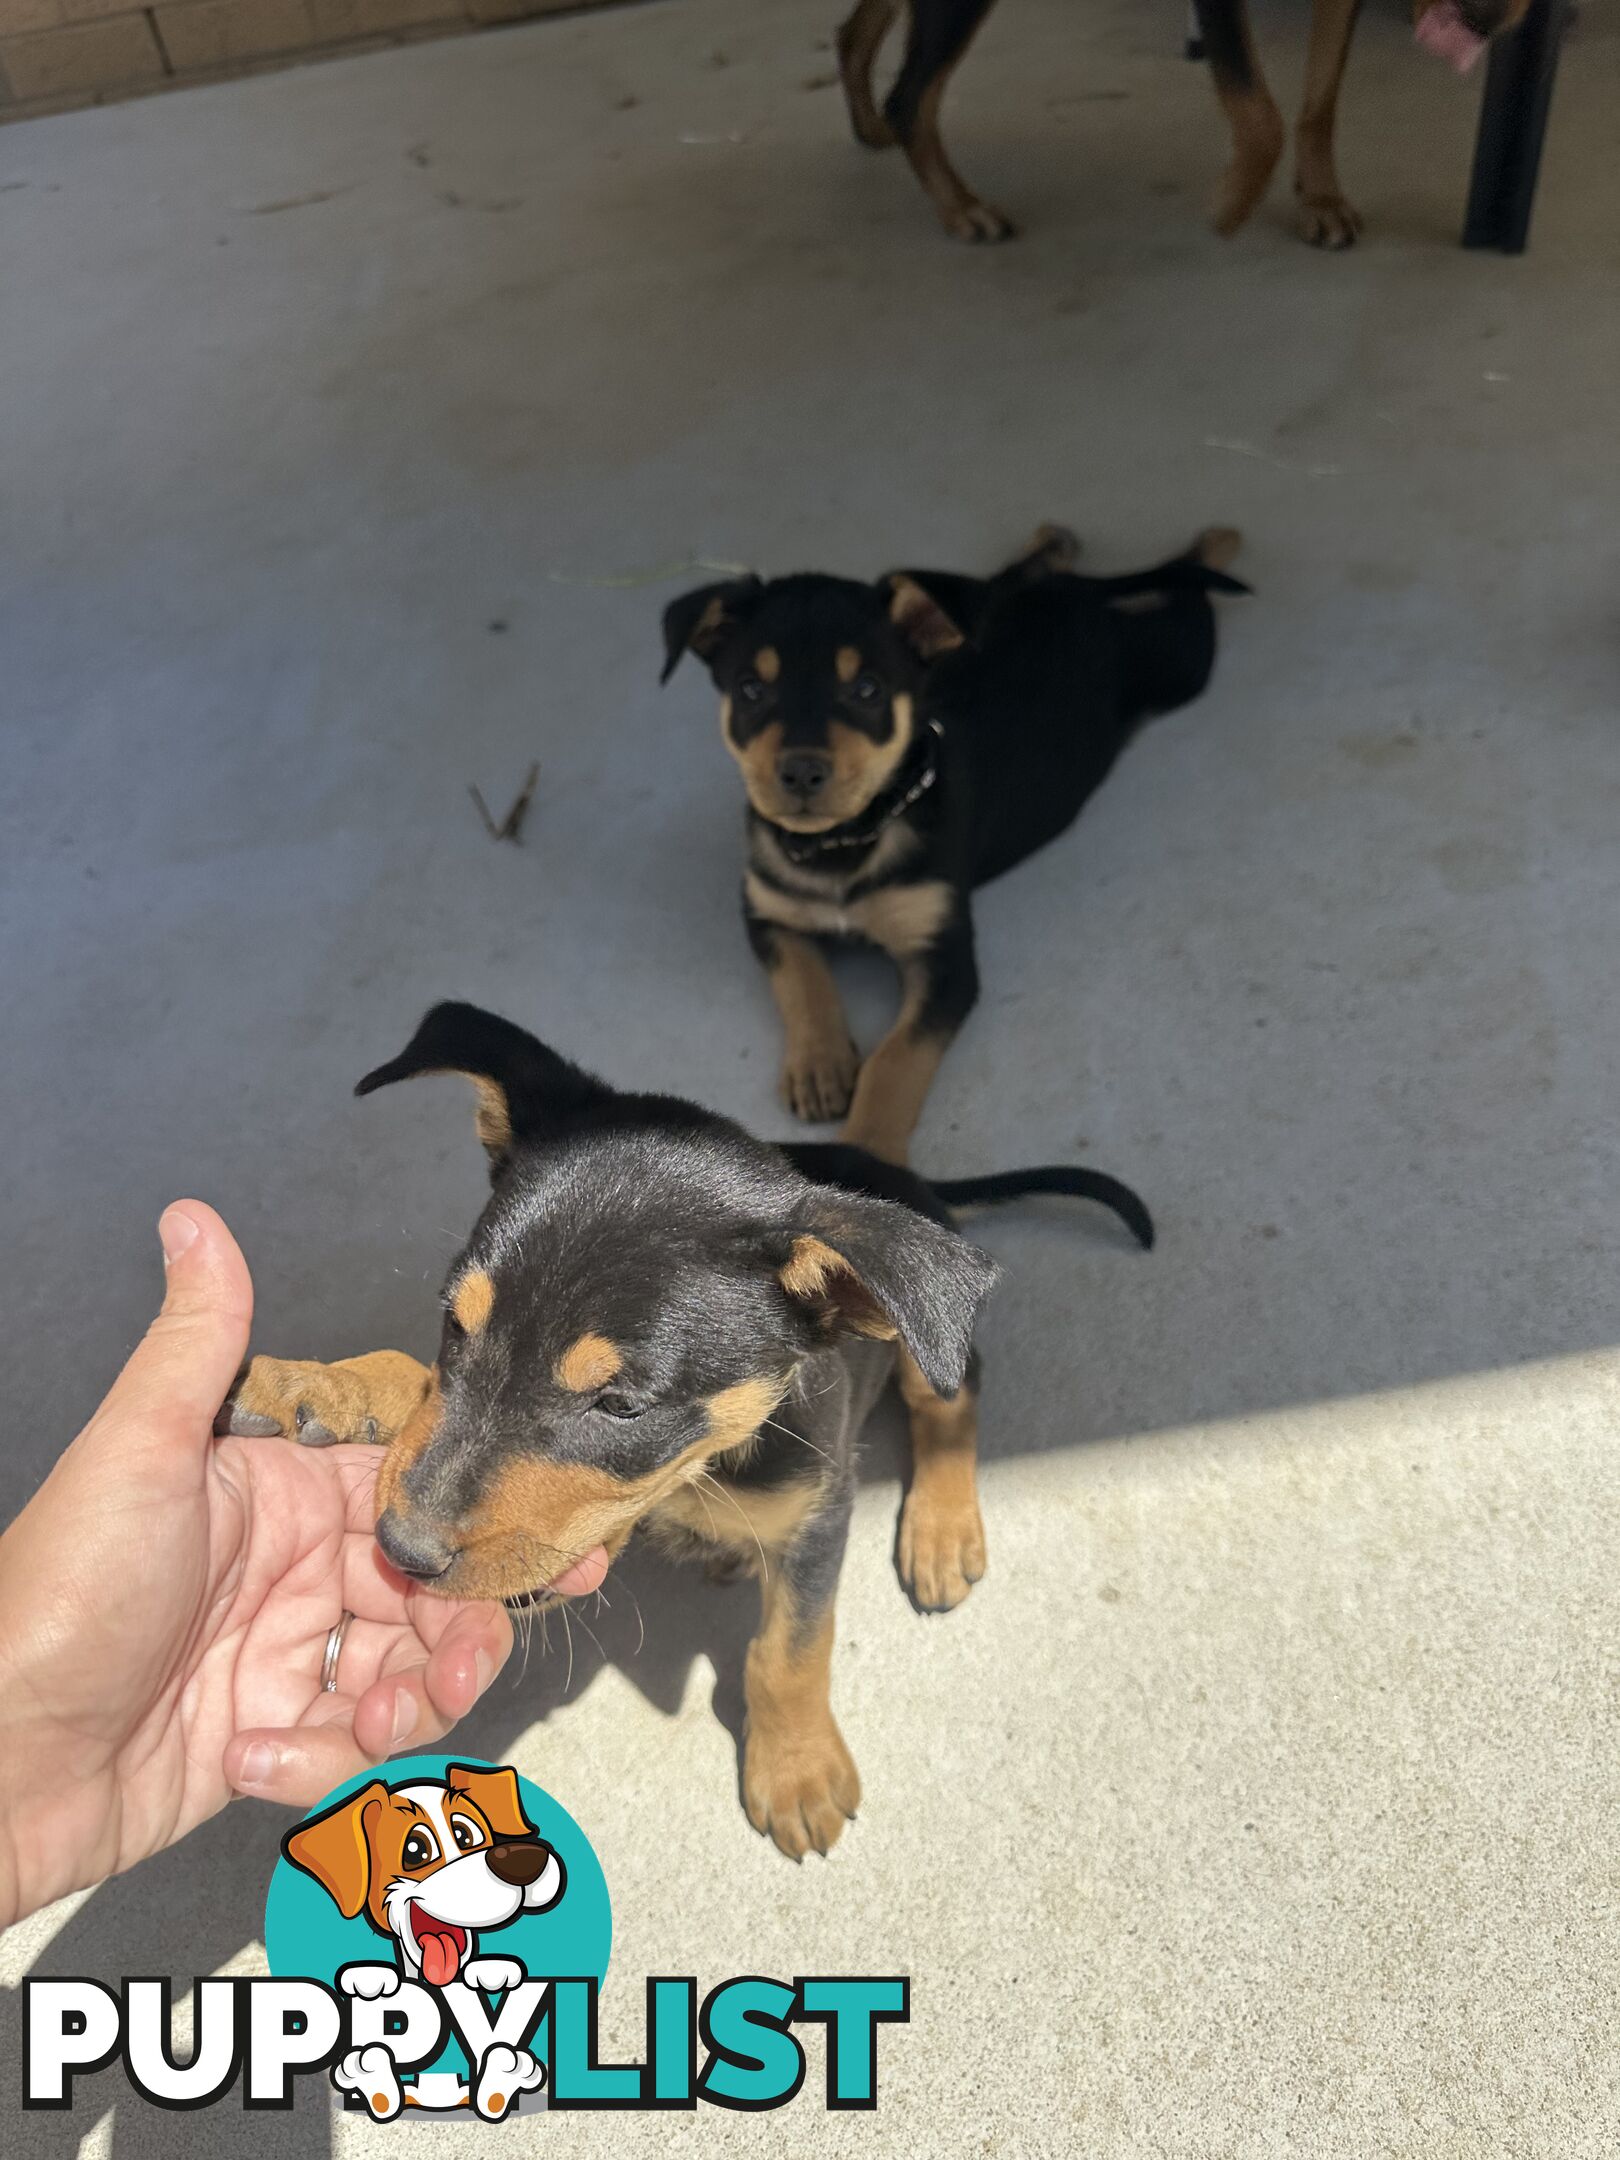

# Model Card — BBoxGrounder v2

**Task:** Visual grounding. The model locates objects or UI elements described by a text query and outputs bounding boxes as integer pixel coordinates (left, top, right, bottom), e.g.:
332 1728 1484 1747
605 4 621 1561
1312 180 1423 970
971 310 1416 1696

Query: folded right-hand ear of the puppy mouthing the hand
778 1192 998 1395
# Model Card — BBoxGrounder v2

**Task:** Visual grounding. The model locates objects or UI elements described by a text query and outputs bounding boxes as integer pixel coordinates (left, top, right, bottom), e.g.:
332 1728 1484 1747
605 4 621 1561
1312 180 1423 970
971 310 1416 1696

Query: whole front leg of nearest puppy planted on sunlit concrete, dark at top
743 1480 860 1860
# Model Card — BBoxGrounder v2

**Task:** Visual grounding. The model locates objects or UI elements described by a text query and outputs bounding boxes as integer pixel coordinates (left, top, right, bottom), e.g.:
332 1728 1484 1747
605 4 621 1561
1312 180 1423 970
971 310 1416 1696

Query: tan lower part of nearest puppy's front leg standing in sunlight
743 1568 860 1860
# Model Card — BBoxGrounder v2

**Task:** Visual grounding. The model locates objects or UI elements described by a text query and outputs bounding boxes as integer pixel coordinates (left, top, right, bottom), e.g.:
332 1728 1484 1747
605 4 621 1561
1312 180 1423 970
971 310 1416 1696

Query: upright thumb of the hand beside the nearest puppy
93 1201 253 1445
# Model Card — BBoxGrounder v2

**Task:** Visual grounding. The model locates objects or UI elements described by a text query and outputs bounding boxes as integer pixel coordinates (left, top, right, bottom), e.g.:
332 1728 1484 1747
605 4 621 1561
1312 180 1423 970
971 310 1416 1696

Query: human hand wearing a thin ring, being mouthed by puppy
0 1201 512 1927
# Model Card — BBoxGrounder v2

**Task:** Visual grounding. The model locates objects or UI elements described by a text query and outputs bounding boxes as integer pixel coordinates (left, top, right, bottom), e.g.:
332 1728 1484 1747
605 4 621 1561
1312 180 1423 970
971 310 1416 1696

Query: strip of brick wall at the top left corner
0 0 609 121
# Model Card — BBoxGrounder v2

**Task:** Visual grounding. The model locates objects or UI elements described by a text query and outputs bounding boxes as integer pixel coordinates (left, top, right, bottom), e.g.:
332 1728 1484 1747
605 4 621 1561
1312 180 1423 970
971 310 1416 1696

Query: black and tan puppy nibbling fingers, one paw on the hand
222 1004 1151 1858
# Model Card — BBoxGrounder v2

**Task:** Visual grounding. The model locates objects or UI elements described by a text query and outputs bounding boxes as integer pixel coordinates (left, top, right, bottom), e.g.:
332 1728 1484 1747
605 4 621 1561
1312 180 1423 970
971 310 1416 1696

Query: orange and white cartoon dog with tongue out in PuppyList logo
281 1763 566 2121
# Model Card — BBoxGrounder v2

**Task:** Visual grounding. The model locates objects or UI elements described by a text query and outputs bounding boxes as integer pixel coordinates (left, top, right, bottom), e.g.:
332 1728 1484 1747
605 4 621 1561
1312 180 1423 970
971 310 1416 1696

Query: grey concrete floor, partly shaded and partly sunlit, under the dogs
0 0 1620 2160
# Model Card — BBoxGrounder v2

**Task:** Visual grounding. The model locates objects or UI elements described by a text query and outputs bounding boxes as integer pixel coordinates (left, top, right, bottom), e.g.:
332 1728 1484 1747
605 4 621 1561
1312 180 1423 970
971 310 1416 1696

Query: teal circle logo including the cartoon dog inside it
264 1754 613 2112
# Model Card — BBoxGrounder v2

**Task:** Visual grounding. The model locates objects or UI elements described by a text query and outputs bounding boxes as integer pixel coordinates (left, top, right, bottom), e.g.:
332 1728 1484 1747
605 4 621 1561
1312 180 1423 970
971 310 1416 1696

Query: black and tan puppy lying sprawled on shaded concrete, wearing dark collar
663 527 1248 1162
